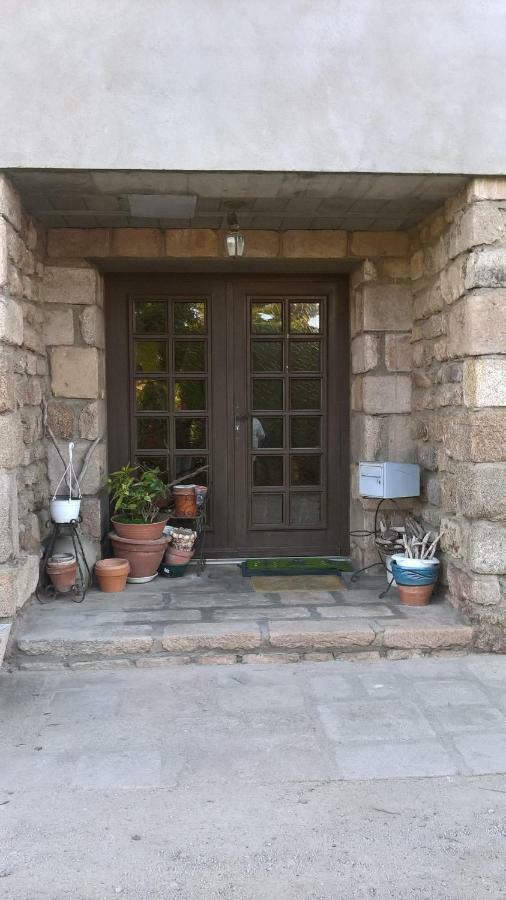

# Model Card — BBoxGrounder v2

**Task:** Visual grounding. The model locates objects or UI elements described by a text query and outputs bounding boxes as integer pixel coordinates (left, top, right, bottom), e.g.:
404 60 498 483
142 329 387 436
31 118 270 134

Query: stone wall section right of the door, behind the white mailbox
350 239 414 565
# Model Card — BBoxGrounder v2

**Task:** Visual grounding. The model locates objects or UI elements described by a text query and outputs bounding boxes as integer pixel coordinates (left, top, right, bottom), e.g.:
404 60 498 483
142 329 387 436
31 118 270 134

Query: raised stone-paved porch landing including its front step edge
11 566 472 668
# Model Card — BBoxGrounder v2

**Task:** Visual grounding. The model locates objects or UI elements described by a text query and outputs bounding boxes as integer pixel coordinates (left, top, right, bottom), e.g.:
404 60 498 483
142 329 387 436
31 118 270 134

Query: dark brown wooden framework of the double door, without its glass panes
105 272 350 558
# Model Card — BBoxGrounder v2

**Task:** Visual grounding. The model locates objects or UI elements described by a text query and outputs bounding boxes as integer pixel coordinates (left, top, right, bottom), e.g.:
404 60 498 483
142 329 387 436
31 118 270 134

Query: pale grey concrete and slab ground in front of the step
0 656 506 900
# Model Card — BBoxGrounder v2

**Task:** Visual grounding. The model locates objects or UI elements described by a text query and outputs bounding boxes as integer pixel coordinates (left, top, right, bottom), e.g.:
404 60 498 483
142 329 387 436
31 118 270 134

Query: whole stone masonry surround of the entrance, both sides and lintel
2 193 498 660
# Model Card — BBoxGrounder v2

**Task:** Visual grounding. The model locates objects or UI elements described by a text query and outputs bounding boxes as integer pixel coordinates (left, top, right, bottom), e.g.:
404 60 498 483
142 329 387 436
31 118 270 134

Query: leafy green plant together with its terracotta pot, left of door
107 465 167 540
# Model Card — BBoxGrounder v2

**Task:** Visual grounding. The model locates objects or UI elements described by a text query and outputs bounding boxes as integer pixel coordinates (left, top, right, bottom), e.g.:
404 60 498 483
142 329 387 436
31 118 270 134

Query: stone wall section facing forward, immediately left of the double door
42 261 107 549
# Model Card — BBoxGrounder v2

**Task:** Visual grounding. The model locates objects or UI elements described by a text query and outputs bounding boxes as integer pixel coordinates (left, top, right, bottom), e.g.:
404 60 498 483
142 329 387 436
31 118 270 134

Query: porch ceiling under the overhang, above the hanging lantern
5 169 467 231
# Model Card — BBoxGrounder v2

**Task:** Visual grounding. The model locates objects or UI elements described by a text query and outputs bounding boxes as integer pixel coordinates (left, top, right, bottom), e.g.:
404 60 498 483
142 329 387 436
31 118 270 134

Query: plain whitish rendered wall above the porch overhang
0 0 506 174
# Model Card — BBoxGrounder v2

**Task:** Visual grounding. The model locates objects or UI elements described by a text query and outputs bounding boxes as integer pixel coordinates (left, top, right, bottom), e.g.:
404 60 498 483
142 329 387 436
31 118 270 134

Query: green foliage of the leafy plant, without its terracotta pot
107 466 167 524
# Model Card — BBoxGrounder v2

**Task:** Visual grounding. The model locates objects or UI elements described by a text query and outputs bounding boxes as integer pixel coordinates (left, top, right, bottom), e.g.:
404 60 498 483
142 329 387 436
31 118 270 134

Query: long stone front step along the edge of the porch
11 610 472 668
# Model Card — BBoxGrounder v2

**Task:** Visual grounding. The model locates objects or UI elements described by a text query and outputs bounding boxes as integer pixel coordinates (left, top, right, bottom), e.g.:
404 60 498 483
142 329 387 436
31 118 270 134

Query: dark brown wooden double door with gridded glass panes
106 274 349 557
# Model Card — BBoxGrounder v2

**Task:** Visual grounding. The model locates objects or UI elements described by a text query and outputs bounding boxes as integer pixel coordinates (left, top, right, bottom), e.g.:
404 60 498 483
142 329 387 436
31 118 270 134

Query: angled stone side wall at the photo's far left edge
0 175 48 663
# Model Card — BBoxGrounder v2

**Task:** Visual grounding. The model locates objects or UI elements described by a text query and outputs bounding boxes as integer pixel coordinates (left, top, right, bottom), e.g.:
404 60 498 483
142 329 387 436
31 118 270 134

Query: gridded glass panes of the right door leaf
248 297 326 530
